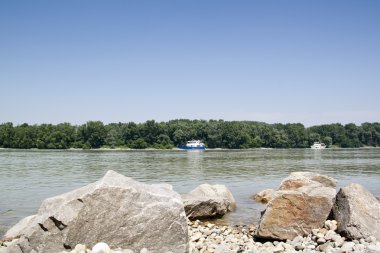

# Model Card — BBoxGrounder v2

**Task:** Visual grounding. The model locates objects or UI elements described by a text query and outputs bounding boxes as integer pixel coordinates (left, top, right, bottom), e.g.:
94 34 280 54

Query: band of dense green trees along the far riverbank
0 119 380 149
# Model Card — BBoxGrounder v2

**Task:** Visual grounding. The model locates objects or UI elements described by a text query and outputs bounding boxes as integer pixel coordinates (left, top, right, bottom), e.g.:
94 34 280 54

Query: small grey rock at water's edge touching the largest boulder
182 184 236 220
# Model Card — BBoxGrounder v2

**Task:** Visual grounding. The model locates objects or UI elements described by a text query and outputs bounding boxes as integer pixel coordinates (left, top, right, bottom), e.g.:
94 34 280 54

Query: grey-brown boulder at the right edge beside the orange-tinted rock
333 184 380 240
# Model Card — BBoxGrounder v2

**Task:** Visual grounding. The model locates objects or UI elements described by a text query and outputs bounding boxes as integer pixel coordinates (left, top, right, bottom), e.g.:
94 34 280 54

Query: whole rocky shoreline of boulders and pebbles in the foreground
0 171 380 253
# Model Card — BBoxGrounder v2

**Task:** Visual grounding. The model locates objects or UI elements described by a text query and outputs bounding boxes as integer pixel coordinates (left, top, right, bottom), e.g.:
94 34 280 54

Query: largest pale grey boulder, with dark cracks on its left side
5 171 188 253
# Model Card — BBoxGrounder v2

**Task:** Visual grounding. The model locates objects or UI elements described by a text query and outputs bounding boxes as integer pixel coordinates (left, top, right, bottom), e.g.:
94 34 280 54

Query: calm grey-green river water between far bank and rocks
0 148 380 238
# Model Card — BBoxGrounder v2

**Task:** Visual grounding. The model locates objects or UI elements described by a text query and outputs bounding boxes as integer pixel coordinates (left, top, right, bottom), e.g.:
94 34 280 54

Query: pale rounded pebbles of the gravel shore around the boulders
0 220 380 253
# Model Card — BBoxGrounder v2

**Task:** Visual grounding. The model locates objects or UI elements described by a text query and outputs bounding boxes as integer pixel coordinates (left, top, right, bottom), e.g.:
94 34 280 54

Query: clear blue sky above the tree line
0 0 380 126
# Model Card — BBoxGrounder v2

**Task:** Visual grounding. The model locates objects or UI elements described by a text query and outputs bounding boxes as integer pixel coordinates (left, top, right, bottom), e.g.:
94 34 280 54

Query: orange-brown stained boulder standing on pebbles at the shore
256 172 336 240
